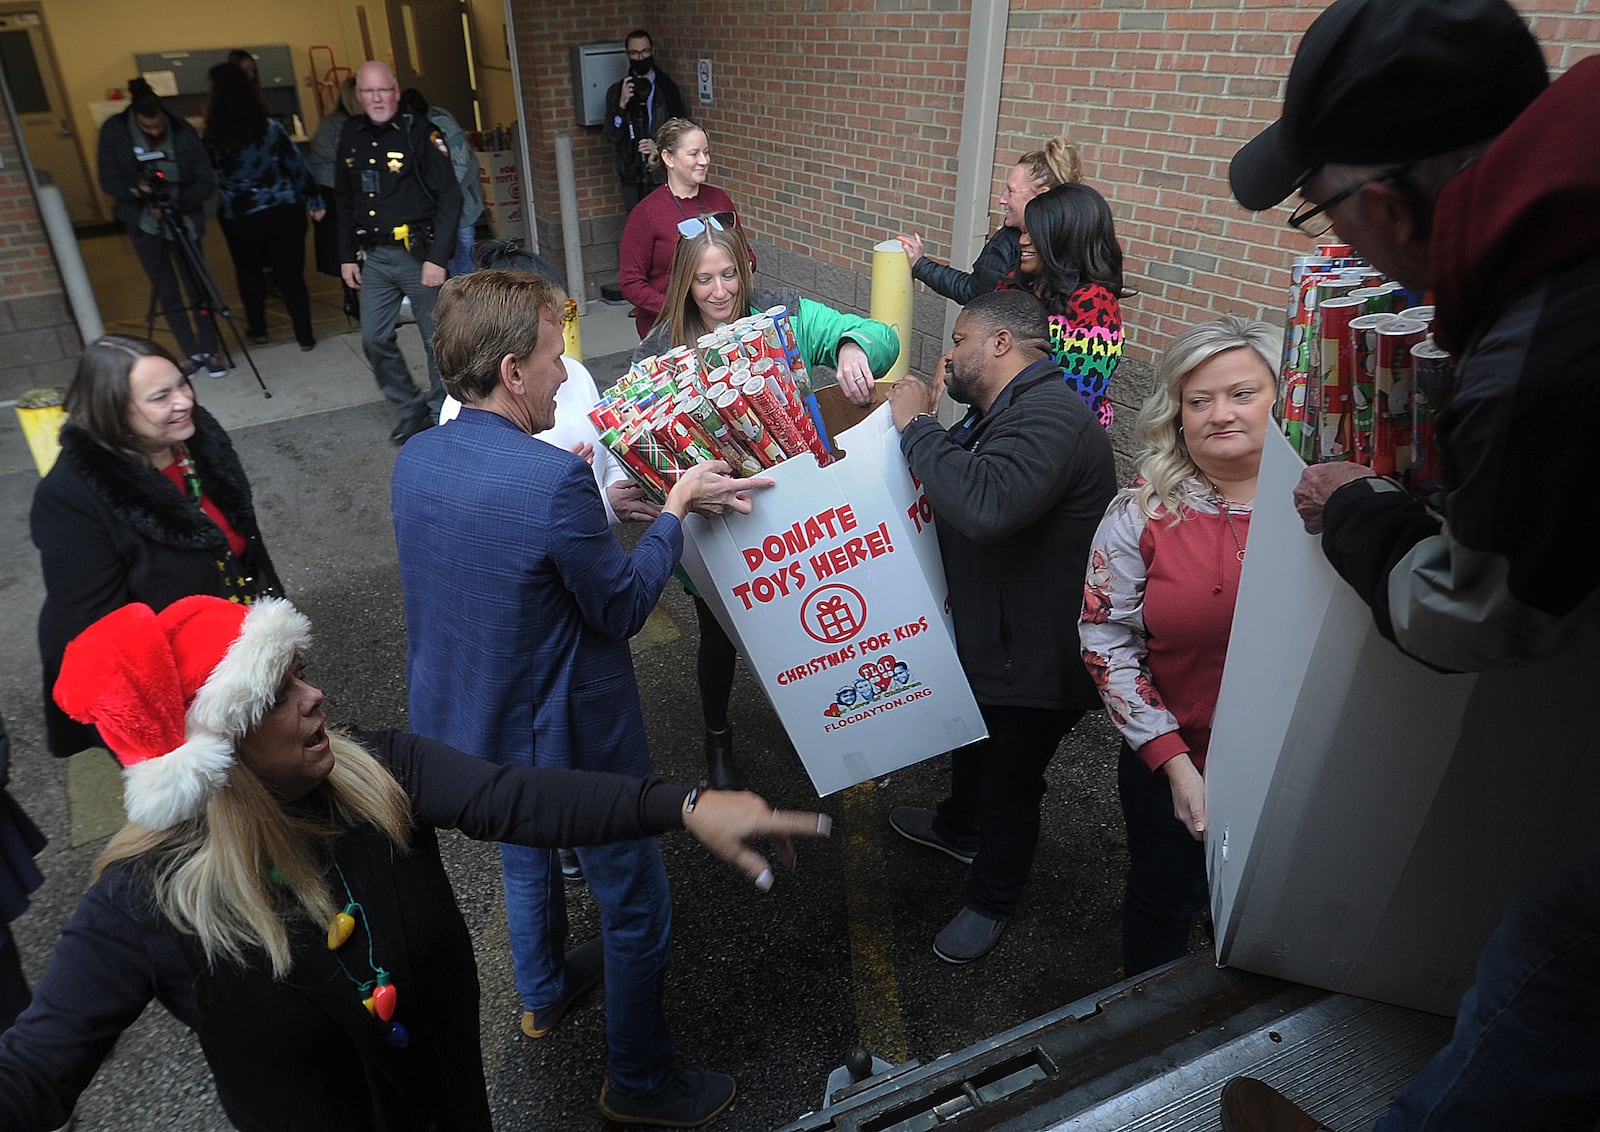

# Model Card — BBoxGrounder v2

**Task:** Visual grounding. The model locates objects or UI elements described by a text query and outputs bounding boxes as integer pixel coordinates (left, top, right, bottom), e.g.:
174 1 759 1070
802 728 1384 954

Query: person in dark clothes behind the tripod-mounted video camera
99 78 227 377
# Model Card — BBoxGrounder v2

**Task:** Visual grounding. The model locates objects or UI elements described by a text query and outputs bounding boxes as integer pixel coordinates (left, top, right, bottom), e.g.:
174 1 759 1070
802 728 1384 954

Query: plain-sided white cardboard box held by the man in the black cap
1206 435 1600 1015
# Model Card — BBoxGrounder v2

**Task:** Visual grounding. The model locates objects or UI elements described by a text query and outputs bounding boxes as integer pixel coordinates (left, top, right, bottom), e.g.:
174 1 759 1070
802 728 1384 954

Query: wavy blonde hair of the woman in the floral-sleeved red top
1125 315 1283 523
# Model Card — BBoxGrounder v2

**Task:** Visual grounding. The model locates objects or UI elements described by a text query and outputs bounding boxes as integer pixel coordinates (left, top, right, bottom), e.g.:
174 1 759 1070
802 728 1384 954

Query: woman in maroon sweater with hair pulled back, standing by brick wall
618 118 755 337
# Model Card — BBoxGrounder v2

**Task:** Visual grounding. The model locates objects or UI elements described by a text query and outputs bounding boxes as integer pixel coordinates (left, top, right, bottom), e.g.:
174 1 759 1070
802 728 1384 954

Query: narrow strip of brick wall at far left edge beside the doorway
0 83 82 400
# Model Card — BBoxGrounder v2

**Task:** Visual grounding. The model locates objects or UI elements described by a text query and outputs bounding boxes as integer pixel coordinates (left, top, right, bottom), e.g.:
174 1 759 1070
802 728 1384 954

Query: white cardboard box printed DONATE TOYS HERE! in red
683 389 987 795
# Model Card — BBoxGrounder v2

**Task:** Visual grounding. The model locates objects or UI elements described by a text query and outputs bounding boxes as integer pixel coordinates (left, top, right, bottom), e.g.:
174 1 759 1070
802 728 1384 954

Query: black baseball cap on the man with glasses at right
1227 0 1550 211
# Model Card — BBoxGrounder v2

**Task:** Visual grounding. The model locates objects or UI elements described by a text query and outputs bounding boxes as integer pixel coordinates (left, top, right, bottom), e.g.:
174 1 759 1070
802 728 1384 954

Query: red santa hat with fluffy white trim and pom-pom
54 595 310 830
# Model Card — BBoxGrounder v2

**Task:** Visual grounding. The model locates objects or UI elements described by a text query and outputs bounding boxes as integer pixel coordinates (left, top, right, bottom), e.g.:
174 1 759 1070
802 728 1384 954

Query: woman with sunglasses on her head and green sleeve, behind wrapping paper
634 217 899 788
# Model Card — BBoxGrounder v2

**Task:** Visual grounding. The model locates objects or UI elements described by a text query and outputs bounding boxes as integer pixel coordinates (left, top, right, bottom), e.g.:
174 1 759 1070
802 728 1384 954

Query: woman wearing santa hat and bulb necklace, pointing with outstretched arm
0 596 829 1132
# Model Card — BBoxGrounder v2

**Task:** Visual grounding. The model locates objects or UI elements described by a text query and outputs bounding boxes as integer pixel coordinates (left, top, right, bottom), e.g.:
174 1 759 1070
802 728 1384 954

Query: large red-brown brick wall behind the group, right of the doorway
514 0 1600 405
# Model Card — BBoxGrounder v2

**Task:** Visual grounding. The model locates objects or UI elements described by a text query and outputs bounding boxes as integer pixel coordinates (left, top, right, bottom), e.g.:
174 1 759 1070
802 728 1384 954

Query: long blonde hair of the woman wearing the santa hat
94 731 411 979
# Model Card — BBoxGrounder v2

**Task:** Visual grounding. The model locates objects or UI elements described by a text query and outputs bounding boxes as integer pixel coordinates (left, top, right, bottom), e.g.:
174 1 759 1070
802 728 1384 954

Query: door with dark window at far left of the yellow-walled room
0 5 104 224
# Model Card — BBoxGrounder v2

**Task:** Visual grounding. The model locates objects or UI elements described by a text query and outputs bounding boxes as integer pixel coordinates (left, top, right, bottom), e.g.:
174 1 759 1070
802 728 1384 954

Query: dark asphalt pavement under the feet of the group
0 304 1125 1130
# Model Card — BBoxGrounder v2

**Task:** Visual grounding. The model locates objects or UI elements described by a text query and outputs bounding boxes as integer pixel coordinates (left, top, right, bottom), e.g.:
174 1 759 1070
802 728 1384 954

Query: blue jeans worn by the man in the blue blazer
501 838 672 1095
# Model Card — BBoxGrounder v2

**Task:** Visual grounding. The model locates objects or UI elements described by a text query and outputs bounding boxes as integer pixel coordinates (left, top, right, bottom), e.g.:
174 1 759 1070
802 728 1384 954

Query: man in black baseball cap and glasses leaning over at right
1222 0 1600 1132
